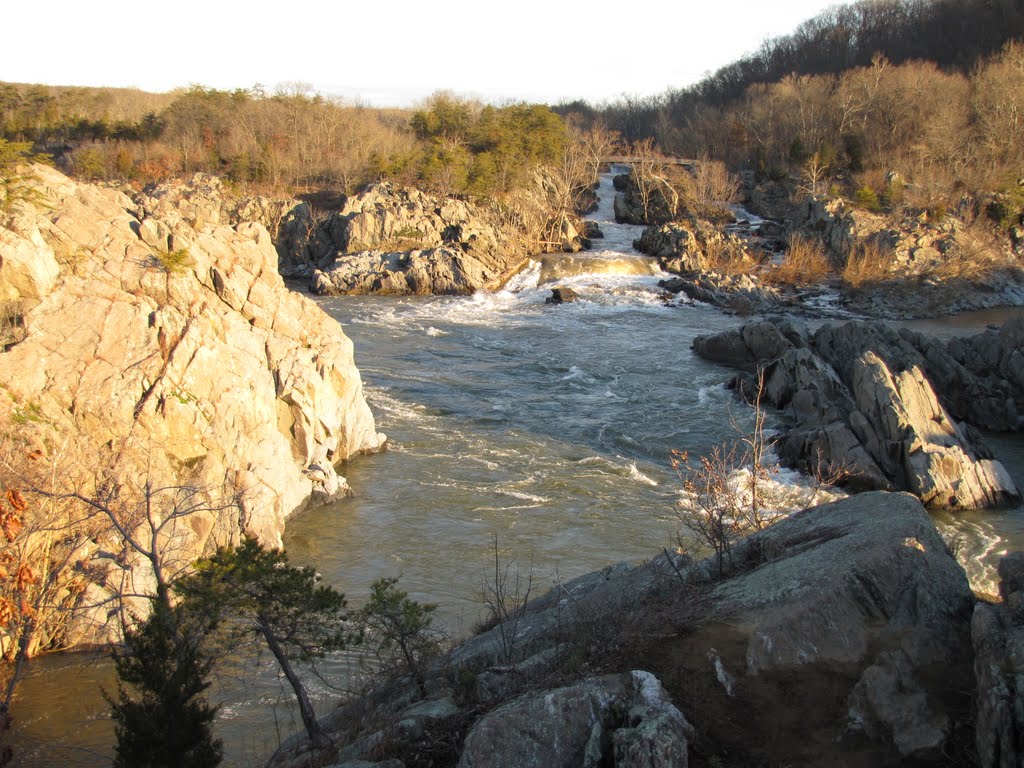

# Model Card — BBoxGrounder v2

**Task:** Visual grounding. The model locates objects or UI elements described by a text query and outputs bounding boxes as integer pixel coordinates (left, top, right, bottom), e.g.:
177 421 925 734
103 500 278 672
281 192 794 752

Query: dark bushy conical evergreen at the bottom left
108 589 221 768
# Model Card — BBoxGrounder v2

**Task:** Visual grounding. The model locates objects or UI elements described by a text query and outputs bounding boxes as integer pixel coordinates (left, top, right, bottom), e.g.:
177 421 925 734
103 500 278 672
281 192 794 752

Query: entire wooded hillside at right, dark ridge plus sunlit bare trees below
559 0 1024 226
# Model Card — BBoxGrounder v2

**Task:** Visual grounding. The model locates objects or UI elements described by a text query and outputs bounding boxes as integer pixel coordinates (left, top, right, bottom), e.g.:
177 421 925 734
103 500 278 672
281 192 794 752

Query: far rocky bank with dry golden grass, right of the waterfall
615 167 1024 318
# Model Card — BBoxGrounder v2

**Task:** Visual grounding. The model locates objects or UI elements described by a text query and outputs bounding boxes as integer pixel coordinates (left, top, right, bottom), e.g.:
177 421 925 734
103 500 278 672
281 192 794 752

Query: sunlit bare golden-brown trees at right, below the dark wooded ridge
675 43 1024 207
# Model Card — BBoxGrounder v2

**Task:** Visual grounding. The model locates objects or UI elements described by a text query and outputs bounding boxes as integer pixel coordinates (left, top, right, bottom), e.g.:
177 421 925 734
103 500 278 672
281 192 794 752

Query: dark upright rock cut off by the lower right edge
971 552 1024 768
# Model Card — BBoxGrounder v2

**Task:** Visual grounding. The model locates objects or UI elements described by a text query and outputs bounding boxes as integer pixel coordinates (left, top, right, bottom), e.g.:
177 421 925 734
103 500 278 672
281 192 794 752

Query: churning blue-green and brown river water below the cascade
9 171 1024 766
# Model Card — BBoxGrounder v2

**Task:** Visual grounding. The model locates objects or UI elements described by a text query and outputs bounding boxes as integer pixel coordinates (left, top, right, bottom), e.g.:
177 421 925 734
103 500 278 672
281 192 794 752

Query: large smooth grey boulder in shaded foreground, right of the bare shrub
696 494 974 764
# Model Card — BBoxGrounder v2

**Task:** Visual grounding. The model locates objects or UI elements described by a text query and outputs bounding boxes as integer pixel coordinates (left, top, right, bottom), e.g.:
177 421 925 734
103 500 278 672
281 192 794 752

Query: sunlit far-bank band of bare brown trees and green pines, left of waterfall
0 83 566 201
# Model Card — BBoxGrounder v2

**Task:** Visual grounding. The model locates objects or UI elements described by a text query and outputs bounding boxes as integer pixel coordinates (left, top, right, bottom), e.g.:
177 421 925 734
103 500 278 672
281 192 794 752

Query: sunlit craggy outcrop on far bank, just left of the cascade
292 173 586 295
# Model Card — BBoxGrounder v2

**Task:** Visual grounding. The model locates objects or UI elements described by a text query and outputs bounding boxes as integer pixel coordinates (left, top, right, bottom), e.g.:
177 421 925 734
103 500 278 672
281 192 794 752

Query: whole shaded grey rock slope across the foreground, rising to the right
270 493 999 768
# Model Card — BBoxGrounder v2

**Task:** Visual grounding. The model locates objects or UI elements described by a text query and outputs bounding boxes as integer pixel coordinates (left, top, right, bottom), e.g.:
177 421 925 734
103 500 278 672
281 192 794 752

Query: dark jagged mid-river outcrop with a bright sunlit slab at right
693 321 1024 508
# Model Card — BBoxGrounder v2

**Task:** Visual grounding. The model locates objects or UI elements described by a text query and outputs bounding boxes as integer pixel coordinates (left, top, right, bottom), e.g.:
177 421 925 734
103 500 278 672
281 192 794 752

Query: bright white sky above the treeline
0 0 836 106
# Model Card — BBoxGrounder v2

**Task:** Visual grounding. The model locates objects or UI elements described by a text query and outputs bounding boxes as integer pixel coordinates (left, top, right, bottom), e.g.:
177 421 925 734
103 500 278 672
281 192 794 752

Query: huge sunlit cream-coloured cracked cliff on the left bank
0 167 384 638
